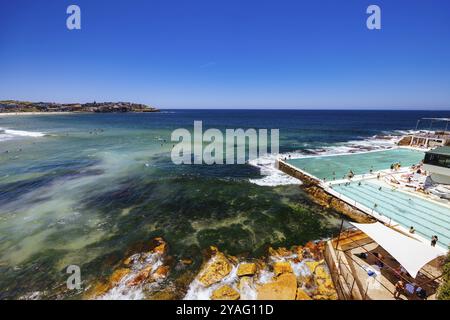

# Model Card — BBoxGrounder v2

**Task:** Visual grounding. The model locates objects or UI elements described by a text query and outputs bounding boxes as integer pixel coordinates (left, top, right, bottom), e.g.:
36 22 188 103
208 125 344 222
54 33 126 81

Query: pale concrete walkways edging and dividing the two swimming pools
278 148 450 254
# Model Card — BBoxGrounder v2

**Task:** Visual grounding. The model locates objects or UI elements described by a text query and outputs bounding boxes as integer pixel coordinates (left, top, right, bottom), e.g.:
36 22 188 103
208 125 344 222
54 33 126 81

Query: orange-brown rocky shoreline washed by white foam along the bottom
83 238 338 300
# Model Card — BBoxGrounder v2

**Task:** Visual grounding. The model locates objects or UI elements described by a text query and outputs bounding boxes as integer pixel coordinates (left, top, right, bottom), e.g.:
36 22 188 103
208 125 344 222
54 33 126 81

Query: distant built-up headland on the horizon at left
0 100 159 113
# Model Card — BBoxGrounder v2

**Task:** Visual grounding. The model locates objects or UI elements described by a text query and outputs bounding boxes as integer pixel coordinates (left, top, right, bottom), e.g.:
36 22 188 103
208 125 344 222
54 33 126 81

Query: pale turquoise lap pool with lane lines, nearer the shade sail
333 181 450 248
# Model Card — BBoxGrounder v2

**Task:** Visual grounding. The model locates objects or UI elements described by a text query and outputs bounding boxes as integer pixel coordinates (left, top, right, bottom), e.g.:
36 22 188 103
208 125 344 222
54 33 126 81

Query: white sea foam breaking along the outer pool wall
249 130 414 186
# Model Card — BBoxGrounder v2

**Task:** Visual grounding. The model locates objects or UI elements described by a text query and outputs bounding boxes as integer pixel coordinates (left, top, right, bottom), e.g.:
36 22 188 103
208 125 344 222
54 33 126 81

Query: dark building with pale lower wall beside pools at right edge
423 146 450 185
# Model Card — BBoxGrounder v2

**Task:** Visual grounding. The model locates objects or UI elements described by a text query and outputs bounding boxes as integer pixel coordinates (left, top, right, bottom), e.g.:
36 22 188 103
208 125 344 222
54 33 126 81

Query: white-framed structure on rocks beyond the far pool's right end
398 118 450 148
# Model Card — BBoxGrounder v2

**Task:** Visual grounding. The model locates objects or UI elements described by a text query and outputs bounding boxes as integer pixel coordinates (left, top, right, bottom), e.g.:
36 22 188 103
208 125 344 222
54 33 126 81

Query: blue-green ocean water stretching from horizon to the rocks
0 110 450 299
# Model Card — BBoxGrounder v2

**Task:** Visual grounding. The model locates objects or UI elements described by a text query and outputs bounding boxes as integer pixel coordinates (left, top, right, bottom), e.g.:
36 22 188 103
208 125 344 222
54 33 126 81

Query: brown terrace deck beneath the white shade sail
324 230 442 300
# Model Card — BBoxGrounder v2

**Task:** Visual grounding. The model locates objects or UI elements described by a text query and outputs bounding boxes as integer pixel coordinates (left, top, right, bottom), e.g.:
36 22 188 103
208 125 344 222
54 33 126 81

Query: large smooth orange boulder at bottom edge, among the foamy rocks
257 273 297 300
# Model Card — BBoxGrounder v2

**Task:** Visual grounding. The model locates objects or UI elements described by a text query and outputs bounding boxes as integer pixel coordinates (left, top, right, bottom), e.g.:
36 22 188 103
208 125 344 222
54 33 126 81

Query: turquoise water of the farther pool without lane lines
287 149 424 180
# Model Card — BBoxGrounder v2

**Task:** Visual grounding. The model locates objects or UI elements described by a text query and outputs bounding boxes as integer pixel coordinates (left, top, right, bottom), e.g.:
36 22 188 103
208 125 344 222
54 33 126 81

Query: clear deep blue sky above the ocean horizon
0 0 450 109
